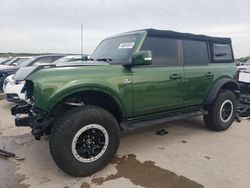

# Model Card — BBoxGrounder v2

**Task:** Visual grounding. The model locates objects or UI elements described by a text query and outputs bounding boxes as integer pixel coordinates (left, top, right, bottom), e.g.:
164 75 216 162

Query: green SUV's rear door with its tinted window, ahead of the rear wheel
182 40 215 106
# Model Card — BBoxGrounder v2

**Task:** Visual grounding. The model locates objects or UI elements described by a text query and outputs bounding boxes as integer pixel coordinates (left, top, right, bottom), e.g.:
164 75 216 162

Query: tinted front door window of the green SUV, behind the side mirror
141 37 178 66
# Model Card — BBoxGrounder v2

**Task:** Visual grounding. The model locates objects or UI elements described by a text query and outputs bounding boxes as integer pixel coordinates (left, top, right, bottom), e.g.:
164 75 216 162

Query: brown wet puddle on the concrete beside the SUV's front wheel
92 154 204 188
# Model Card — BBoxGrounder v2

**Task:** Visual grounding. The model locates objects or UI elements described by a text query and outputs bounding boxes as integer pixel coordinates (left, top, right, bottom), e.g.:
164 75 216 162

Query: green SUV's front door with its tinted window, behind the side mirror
131 37 184 116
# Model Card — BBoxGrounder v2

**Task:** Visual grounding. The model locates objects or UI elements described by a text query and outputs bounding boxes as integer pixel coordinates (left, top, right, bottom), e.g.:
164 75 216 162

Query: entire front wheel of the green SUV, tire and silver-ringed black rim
50 105 120 177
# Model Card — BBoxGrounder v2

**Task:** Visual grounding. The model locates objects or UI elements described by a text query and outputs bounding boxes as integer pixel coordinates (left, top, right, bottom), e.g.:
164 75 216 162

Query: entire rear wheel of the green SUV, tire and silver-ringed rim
204 90 237 131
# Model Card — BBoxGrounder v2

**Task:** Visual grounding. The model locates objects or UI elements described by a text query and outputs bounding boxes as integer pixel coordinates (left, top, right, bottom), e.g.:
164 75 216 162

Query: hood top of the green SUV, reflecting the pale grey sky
14 61 109 81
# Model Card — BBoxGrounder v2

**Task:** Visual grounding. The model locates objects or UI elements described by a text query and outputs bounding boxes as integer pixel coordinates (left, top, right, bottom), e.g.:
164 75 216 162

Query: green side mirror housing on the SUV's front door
132 51 152 65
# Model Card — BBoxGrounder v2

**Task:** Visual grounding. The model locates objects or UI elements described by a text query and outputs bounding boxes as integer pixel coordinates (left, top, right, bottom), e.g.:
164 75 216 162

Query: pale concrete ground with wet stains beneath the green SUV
0 100 250 188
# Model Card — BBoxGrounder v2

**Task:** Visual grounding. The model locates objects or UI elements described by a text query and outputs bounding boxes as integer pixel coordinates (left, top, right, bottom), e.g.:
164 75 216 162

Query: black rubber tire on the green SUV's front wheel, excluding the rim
49 105 120 177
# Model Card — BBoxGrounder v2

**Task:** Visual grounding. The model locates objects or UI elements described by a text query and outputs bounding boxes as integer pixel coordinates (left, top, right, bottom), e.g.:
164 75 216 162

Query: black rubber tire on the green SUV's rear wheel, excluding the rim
204 90 237 131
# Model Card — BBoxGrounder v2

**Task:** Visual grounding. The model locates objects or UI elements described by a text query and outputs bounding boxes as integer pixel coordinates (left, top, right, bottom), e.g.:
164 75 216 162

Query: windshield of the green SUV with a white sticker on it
91 35 139 62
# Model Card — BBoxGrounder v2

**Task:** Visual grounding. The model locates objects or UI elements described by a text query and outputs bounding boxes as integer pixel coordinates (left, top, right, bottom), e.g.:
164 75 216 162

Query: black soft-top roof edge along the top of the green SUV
145 29 231 44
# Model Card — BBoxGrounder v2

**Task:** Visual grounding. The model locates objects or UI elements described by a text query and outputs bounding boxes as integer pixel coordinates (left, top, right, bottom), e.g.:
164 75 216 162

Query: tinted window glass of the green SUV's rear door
182 40 209 65
